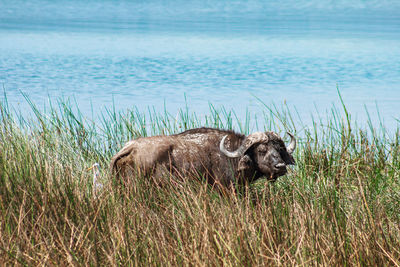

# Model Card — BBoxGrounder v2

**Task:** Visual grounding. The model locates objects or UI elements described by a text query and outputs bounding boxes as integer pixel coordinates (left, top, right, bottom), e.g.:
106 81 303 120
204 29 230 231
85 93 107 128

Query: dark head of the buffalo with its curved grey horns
220 132 296 181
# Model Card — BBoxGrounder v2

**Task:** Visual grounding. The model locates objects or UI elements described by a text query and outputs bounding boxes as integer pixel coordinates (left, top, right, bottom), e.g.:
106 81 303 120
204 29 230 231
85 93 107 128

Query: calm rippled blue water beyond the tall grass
0 0 400 129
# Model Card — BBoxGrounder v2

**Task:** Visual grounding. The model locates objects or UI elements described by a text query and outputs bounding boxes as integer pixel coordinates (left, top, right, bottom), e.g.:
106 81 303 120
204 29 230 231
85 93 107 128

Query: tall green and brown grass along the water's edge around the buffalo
0 96 400 266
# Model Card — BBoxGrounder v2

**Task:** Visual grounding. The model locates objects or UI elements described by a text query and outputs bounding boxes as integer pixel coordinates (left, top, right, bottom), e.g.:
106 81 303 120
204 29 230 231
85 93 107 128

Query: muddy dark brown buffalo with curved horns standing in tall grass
111 128 296 187
